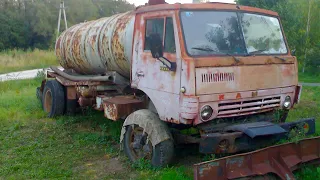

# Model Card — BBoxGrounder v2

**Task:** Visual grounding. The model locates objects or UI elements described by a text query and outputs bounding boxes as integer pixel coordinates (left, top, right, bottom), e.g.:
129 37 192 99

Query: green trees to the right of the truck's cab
236 0 320 74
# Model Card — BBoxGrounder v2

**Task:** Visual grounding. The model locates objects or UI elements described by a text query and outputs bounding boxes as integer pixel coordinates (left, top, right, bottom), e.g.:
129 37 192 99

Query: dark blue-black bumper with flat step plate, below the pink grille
199 118 315 154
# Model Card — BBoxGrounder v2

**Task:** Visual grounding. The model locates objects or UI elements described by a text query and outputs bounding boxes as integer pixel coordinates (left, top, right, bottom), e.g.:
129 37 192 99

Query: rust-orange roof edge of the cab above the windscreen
135 2 279 16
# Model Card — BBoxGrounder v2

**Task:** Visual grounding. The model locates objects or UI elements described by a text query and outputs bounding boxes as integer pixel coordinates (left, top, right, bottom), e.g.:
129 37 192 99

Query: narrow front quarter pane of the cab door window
164 17 176 53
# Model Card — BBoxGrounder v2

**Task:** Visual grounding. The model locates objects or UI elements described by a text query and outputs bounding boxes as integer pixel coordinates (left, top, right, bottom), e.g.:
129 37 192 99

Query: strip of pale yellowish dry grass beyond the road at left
0 49 59 74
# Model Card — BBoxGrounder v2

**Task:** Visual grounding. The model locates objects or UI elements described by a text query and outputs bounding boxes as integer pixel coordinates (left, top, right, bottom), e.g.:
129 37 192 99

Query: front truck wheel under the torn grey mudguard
123 110 174 167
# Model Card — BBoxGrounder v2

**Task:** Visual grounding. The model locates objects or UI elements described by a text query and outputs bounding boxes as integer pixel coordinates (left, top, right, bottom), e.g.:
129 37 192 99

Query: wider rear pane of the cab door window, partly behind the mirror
144 18 164 50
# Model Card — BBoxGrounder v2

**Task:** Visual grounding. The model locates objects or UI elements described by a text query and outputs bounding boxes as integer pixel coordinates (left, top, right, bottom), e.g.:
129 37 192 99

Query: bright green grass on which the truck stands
0 79 320 180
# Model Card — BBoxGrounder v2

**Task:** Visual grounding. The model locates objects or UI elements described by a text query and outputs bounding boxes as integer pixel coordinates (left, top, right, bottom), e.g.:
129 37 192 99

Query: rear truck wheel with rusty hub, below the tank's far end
42 80 65 117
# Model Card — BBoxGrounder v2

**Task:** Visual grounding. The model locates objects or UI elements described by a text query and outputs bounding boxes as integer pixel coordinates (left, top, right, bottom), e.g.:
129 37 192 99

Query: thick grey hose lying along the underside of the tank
50 66 113 81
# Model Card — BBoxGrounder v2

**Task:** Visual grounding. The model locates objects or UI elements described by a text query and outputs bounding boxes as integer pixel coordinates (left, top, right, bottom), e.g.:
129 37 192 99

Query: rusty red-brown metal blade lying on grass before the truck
194 137 320 180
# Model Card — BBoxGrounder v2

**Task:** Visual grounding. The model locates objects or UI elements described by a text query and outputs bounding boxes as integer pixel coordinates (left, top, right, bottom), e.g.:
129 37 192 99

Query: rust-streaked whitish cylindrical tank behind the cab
55 12 135 78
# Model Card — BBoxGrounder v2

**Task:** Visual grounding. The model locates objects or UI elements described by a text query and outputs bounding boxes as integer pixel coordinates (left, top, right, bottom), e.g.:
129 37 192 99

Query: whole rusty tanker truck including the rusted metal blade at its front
37 3 319 179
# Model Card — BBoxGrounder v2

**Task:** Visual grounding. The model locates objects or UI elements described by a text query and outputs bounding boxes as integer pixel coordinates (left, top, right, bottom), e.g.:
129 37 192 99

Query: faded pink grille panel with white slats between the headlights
194 86 301 125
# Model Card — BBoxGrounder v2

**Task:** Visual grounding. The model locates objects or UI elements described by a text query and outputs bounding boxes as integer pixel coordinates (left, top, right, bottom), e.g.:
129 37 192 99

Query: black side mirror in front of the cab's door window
149 33 163 58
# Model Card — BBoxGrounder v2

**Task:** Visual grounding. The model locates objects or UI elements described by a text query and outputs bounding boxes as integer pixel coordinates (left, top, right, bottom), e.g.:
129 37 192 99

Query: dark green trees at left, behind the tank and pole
0 0 134 51
